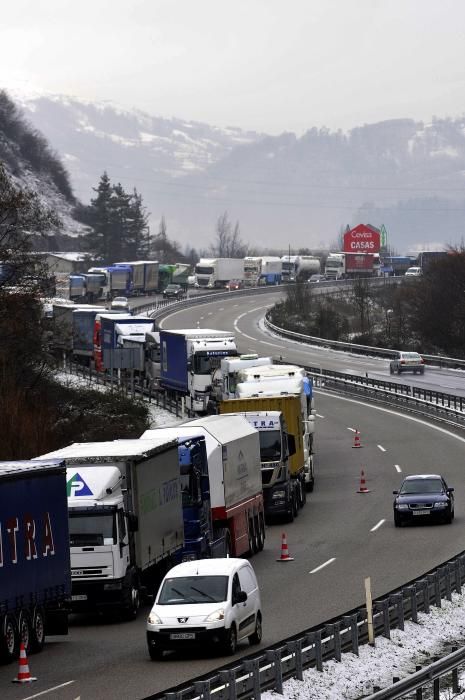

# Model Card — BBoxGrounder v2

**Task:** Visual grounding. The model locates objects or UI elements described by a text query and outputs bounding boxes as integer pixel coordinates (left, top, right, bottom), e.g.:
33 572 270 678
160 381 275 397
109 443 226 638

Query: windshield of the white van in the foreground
158 576 228 605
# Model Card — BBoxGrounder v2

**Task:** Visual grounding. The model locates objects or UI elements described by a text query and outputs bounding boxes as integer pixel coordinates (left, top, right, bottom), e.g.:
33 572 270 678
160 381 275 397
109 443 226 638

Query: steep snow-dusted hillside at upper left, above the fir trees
0 91 88 250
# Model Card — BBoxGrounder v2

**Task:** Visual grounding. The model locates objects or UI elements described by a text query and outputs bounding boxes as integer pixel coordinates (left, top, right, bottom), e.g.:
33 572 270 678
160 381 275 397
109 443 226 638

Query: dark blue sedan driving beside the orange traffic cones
393 474 454 527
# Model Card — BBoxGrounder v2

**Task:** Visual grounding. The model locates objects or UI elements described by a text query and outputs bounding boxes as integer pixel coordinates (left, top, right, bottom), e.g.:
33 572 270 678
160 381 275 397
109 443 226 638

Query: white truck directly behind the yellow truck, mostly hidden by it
232 364 316 491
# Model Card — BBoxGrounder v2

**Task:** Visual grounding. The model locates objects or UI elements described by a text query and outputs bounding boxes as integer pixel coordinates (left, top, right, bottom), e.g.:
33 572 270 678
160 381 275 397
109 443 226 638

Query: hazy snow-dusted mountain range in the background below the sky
10 95 465 252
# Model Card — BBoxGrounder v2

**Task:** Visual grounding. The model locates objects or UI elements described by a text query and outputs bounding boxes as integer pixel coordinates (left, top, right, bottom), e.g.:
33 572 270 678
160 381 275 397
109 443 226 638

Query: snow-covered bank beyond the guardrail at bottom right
261 593 465 700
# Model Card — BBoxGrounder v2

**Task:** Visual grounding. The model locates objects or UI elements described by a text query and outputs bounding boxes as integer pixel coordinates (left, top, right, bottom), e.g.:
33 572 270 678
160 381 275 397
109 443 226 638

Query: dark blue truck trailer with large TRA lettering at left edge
0 460 71 663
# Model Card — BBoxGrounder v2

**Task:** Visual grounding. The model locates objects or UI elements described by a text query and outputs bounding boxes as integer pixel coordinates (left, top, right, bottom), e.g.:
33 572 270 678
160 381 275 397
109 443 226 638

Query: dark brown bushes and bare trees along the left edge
0 163 149 460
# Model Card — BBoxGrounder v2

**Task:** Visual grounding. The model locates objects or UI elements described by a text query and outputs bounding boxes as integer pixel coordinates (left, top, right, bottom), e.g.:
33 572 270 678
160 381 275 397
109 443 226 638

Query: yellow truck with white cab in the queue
219 395 306 522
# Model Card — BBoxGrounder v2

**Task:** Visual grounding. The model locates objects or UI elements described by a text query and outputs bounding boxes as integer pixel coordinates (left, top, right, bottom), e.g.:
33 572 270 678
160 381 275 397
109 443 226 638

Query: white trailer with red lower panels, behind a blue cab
141 415 265 557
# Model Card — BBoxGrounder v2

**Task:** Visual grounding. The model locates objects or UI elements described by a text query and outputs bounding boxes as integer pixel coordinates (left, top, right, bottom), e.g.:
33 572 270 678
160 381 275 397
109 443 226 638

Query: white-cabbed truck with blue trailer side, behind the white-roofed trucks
160 328 237 413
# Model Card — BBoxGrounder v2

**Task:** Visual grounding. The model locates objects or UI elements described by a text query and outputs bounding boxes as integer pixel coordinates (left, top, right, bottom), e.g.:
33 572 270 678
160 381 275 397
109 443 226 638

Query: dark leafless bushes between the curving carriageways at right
269 252 465 358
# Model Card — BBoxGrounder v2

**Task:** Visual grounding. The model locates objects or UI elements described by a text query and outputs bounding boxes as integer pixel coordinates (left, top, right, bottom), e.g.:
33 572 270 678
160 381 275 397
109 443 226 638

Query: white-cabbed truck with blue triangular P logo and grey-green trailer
38 436 184 619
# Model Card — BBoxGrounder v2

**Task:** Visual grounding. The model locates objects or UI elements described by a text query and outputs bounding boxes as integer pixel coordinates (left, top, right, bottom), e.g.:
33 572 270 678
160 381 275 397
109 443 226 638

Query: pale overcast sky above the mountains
0 0 465 134
